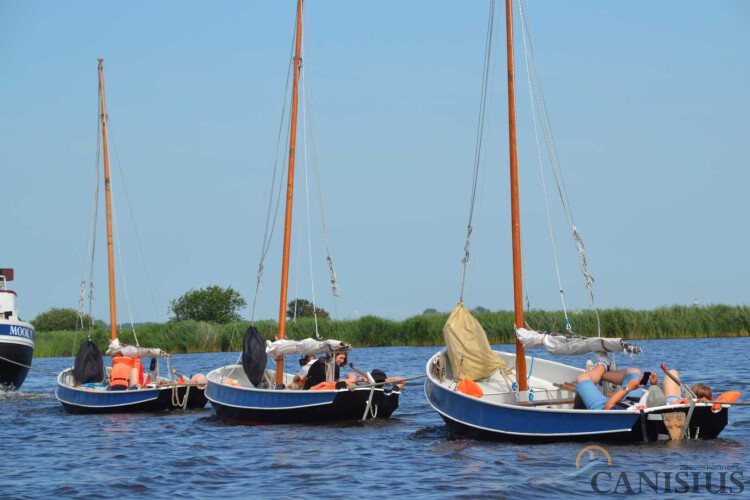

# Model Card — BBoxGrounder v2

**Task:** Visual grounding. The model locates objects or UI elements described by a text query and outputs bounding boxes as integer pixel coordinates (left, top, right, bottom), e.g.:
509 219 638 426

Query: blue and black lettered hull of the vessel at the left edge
0 321 34 390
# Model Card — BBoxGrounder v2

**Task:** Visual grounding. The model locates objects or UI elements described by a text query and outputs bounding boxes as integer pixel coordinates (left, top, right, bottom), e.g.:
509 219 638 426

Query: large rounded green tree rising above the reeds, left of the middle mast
169 285 247 323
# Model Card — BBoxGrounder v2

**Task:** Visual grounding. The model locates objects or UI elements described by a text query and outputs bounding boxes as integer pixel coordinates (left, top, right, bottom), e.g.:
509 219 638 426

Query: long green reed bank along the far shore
34 305 750 357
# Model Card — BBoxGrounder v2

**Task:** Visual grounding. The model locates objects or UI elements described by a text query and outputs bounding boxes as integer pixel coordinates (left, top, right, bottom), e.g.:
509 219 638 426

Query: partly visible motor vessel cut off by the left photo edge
0 268 34 390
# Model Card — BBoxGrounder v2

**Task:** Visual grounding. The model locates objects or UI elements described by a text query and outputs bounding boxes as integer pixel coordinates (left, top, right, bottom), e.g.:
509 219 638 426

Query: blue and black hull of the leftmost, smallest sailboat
55 369 208 414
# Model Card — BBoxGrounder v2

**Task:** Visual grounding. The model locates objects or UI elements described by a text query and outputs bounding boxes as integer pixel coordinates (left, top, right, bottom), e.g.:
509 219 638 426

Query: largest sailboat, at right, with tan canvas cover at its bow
424 0 728 442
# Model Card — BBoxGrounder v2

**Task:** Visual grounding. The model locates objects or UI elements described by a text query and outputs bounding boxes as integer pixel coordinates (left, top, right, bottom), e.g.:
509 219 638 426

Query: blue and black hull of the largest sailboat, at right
425 353 728 442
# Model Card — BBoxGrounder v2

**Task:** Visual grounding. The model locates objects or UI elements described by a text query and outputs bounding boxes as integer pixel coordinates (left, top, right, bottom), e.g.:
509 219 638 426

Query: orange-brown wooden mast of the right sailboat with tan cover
505 0 529 391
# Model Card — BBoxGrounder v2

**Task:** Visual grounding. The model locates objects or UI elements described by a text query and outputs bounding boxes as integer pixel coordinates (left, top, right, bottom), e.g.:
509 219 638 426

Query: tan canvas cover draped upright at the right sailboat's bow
443 304 505 380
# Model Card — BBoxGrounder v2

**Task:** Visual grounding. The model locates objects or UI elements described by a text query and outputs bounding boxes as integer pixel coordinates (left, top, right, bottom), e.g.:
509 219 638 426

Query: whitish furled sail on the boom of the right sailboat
516 328 642 356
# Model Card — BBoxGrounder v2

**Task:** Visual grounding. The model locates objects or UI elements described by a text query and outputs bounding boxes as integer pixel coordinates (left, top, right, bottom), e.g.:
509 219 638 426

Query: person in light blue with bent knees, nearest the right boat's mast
573 353 643 410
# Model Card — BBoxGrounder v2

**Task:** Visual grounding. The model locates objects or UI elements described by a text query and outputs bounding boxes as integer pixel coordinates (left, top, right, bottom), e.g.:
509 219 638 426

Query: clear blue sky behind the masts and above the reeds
0 0 750 321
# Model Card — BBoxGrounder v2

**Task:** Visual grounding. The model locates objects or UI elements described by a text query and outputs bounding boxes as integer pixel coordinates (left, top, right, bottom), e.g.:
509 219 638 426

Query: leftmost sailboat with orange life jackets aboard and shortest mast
55 59 207 414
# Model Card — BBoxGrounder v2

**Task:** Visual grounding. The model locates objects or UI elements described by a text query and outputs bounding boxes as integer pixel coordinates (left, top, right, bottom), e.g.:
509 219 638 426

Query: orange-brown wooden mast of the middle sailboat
276 0 303 385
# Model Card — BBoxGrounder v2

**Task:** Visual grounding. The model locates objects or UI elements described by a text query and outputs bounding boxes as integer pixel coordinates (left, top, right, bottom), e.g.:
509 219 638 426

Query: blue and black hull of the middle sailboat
206 366 400 425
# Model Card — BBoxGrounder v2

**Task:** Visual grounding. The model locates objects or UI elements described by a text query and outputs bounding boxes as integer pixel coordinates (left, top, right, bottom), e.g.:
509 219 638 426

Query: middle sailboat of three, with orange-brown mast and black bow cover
206 0 401 425
